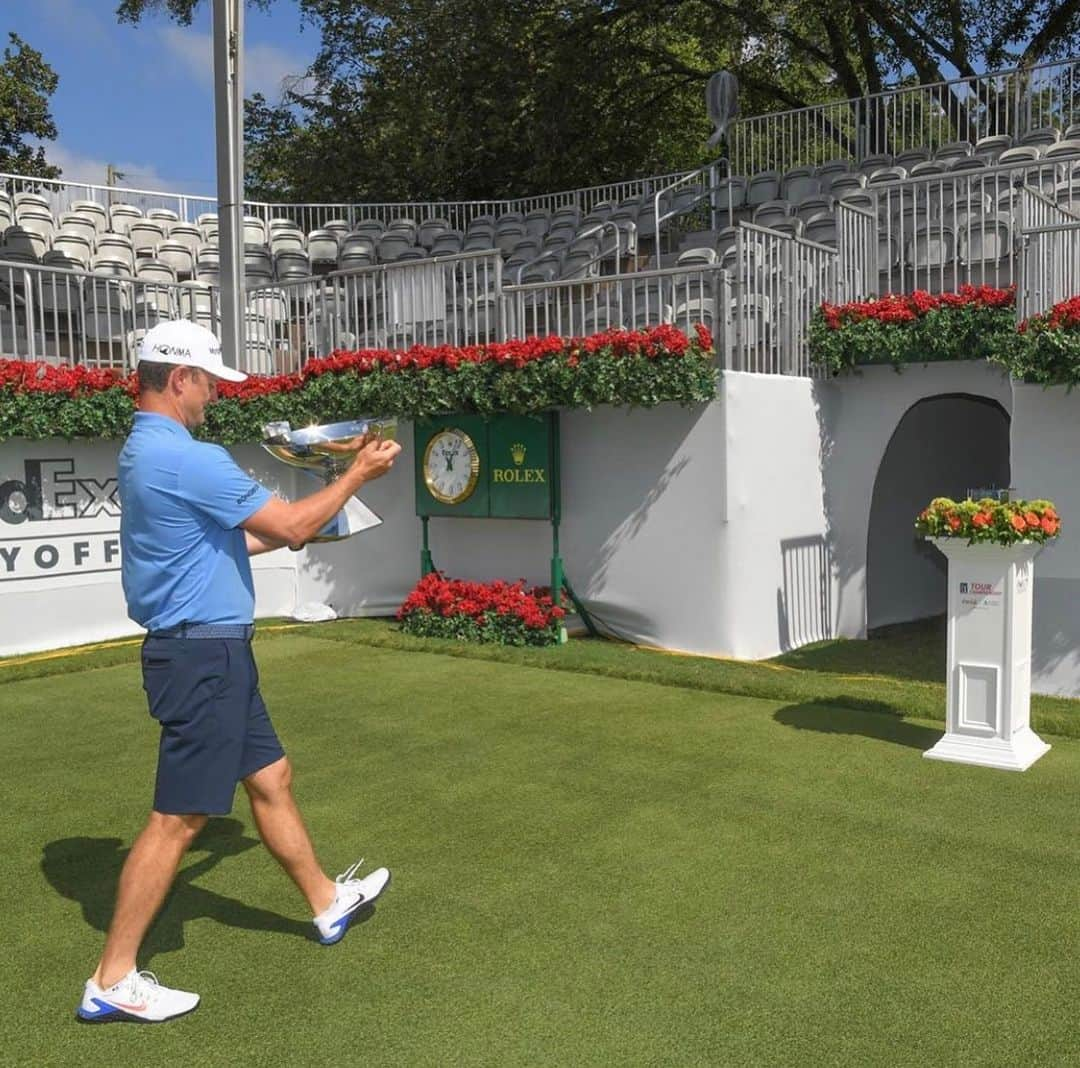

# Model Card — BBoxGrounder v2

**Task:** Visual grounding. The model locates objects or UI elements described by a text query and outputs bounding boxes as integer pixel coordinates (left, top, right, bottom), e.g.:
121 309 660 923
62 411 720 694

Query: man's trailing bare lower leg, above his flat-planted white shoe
93 812 206 989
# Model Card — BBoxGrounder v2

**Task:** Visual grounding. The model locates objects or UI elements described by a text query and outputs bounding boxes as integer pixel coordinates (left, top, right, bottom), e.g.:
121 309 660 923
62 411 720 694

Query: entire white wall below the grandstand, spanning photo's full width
0 363 1080 693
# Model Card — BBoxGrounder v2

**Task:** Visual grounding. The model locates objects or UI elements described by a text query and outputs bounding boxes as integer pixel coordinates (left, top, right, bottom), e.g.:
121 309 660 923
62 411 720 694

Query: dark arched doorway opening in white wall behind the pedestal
866 394 1010 630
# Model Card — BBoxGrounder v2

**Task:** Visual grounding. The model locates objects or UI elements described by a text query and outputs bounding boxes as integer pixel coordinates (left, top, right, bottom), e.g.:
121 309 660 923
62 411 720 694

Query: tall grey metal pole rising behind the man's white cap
213 0 244 367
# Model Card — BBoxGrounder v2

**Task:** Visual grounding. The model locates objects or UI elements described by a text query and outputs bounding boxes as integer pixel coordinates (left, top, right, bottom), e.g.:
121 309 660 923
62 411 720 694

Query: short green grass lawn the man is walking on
0 623 1080 1066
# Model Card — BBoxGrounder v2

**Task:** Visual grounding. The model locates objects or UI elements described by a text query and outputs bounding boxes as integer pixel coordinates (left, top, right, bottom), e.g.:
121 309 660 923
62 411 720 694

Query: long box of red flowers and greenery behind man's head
0 325 717 445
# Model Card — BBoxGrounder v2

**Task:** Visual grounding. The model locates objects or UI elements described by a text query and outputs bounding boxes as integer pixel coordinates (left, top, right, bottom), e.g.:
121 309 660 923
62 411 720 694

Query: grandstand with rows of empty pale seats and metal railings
6 60 1080 375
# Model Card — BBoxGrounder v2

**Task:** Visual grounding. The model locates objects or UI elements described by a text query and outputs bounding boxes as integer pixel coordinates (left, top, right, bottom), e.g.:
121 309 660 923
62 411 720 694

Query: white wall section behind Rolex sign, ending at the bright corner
299 403 725 651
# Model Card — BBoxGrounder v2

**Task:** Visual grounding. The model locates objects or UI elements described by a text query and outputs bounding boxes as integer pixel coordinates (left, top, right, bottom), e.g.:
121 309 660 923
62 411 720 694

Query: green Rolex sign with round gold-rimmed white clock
414 413 558 519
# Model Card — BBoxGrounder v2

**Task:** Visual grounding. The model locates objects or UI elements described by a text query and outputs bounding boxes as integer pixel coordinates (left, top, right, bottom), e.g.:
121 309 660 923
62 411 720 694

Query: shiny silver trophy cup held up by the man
262 417 397 541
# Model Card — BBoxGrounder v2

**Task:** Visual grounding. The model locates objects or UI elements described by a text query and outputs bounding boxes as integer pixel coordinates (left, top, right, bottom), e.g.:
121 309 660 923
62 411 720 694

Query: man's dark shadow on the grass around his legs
41 819 374 960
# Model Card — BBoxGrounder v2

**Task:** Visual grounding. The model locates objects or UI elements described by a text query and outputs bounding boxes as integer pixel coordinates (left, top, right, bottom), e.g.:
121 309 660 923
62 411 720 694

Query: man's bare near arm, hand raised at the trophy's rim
241 438 402 553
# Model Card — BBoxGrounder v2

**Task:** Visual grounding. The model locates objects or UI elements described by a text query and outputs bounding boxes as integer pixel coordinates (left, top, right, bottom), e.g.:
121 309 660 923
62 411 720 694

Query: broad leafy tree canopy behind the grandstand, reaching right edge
113 0 1080 201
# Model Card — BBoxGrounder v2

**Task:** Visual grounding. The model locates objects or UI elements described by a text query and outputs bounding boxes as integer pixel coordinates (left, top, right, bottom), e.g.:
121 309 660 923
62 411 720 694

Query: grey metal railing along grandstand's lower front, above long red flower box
0 207 874 375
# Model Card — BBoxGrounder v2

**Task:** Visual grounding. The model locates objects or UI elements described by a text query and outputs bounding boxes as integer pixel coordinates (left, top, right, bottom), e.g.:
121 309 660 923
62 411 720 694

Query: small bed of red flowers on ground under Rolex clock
397 571 566 646
